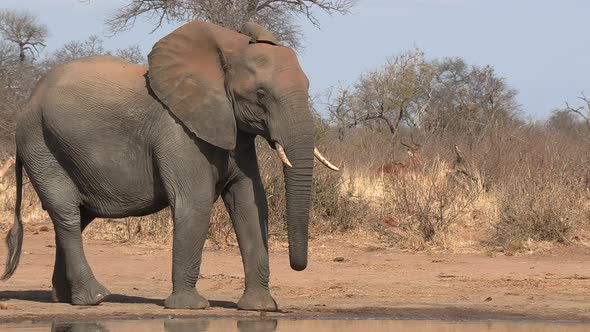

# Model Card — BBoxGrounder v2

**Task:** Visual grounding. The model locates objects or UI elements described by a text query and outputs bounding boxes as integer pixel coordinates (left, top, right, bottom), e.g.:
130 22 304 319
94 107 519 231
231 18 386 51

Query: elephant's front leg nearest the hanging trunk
223 176 277 311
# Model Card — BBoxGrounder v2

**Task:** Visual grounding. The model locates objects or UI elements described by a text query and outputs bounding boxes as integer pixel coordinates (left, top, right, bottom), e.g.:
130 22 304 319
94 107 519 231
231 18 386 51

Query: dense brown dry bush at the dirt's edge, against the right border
495 130 590 252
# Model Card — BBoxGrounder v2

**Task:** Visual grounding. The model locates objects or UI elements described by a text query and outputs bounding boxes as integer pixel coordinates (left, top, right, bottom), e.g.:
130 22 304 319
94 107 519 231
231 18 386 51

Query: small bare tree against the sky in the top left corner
0 10 49 63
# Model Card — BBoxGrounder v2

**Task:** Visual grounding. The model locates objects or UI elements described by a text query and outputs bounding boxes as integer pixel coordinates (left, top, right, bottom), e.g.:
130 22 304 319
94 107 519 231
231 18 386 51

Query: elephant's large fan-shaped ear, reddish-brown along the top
148 21 248 150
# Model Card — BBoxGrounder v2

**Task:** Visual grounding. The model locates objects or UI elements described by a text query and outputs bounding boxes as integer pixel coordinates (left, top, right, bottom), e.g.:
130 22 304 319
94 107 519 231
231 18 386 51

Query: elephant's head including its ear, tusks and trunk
148 21 337 271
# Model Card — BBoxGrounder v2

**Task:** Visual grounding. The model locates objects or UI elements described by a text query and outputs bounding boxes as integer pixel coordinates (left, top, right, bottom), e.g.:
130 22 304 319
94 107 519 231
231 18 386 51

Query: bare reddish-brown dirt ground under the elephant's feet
0 229 590 322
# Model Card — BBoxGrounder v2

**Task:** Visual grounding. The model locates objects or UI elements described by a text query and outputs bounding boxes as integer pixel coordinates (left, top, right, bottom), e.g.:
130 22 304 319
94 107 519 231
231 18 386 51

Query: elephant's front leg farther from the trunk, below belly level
164 201 213 309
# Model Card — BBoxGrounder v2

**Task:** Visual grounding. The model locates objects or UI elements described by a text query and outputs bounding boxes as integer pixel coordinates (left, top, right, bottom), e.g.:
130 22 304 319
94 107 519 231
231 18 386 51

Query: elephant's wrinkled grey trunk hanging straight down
279 97 314 271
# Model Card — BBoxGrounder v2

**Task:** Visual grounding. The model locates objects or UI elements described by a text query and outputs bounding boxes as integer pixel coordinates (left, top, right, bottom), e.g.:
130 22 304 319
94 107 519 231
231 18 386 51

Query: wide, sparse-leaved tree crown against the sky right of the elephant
324 49 524 154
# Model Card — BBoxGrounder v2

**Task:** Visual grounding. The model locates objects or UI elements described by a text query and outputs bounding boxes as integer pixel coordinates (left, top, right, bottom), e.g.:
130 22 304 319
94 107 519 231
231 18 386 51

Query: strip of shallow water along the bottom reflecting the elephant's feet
9 317 590 332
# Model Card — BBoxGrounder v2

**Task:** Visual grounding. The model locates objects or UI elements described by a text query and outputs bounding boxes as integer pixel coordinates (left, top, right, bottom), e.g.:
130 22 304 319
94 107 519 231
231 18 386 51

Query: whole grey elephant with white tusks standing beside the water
2 21 337 311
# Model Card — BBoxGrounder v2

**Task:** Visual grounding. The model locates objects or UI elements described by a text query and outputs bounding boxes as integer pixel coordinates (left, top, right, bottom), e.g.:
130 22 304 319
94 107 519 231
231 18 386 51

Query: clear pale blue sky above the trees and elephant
0 0 590 119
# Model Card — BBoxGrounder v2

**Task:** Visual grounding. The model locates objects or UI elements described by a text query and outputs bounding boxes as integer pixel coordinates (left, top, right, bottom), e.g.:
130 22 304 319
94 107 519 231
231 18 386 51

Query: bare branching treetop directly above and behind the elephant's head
94 0 357 48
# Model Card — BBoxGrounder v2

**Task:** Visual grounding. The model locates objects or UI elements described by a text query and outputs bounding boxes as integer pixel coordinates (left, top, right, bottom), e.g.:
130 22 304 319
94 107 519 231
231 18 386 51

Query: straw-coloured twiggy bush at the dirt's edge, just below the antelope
381 159 483 249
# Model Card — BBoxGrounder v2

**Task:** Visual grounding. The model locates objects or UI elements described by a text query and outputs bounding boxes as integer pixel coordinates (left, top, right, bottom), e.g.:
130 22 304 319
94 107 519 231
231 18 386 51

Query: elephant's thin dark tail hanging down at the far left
0 153 23 281
